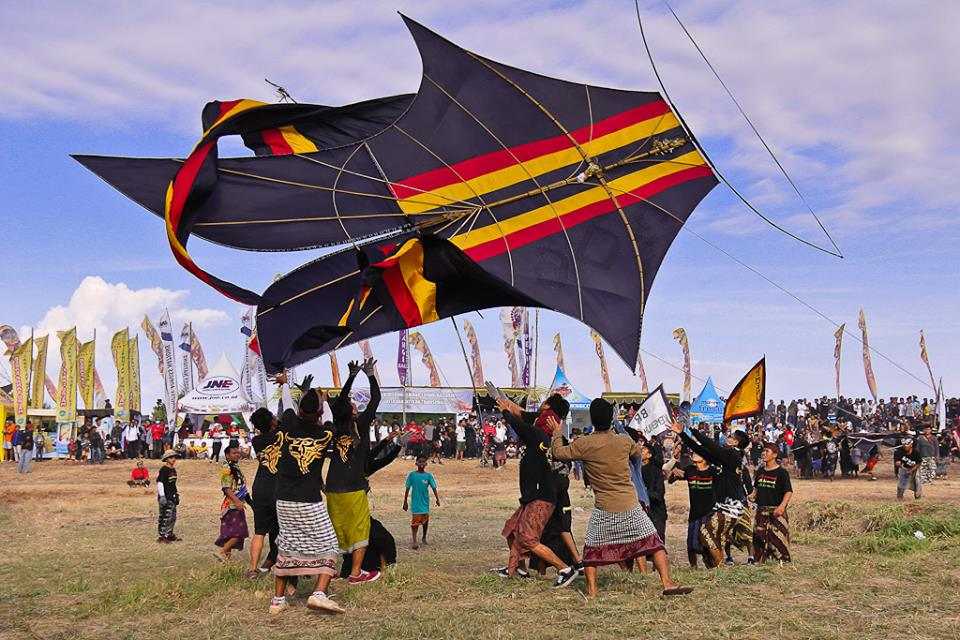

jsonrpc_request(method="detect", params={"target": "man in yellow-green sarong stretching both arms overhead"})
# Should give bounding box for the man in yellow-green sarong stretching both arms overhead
[326,358,380,584]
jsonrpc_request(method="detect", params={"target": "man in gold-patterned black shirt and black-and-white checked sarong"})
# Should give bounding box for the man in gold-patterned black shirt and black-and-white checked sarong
[270,389,343,614]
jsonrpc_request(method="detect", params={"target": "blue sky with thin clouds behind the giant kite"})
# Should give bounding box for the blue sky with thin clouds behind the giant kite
[0,0,960,400]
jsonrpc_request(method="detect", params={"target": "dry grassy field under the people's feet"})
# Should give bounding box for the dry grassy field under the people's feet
[0,460,960,640]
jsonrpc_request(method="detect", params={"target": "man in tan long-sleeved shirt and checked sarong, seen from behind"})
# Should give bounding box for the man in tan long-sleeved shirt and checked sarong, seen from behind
[549,398,693,598]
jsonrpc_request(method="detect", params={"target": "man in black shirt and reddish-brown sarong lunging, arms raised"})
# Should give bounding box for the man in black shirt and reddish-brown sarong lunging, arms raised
[497,394,578,587]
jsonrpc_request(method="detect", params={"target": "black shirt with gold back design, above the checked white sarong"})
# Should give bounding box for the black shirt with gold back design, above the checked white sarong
[276,415,333,502]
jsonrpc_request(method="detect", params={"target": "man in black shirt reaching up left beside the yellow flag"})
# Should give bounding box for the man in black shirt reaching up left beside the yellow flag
[670,422,753,566]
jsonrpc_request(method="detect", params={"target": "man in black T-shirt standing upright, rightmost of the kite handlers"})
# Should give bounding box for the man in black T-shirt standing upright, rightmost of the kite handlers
[751,442,793,562]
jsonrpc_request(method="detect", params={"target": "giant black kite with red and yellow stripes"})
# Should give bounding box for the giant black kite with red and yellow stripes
[79,18,717,371]
